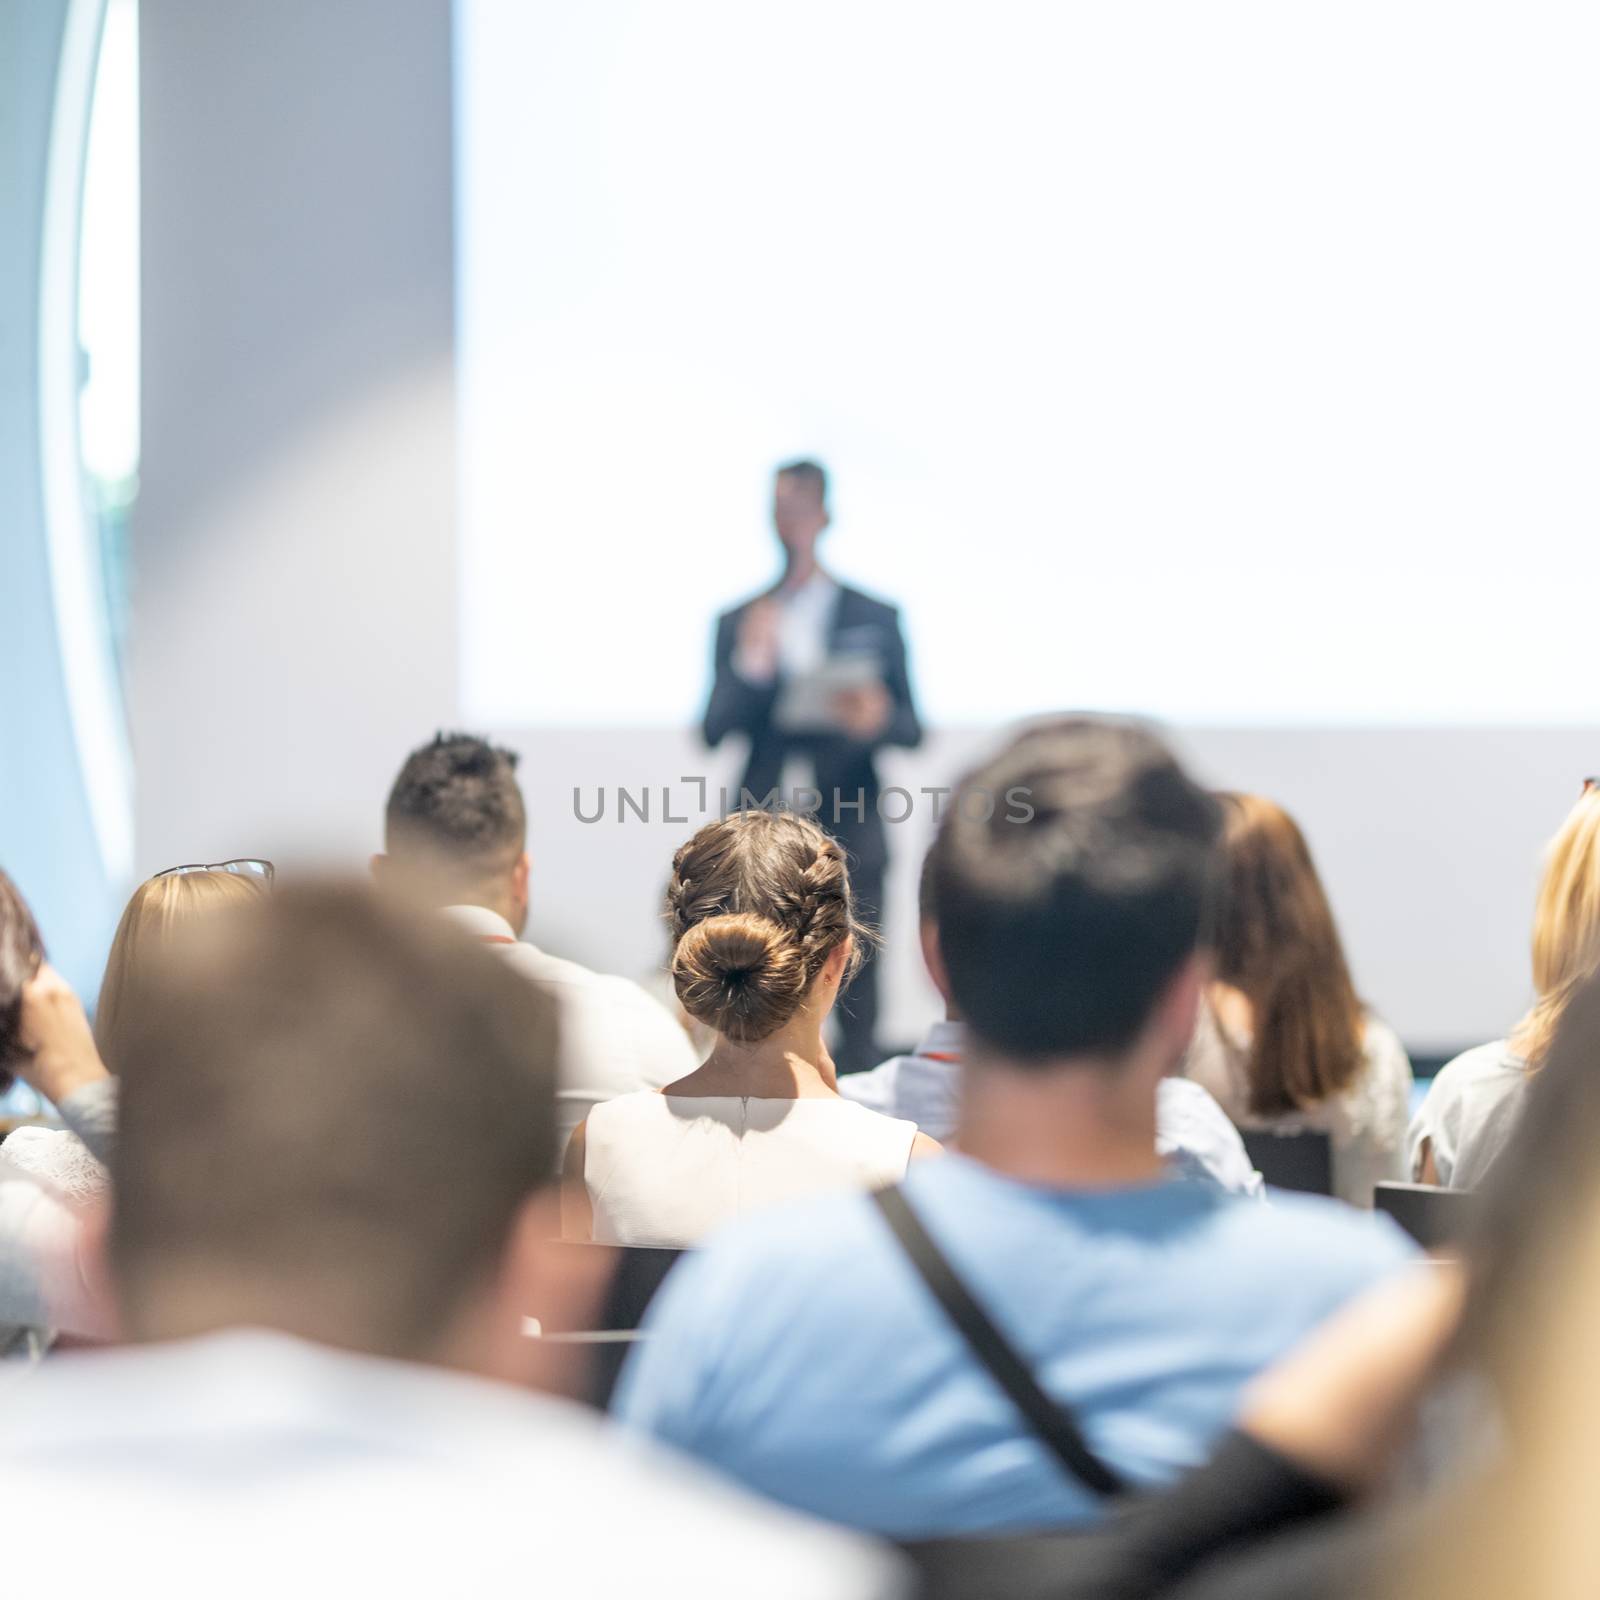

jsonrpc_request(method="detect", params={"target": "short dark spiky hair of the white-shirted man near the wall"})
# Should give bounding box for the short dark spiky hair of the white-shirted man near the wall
[384,733,528,869]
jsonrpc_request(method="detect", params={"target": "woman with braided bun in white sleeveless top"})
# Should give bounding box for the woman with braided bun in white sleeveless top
[565,811,939,1246]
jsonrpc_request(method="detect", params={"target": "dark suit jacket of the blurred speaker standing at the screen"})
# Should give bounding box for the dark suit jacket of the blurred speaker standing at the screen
[701,584,922,869]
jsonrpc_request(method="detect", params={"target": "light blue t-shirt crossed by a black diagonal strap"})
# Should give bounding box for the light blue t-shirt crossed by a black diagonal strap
[616,1154,1416,1538]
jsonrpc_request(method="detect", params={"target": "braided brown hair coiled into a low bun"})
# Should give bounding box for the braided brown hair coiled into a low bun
[667,811,870,1043]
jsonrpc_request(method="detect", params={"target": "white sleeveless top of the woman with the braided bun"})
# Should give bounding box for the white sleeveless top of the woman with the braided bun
[584,1091,917,1248]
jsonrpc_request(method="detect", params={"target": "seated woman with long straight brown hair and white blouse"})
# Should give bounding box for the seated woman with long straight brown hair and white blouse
[1184,795,1411,1206]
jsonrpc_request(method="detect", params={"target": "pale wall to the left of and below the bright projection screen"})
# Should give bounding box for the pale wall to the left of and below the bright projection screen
[131,9,1600,1050]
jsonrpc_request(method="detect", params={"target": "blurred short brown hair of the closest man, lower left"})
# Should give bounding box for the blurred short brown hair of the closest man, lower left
[109,885,557,1360]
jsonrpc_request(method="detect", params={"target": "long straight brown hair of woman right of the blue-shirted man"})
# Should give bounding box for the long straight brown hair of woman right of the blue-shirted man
[1216,794,1363,1117]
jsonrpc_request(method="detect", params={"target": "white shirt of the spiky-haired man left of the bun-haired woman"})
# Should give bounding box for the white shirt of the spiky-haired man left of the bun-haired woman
[445,906,699,1154]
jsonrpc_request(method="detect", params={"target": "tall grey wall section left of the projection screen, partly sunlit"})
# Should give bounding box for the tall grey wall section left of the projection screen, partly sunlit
[130,0,456,872]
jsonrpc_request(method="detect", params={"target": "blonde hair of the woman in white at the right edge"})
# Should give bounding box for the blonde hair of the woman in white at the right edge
[1510,789,1600,1067]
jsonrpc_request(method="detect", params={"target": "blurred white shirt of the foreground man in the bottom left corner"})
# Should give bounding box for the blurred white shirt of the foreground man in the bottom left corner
[0,1331,901,1600]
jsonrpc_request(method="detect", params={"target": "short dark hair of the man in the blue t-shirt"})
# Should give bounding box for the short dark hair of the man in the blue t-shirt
[930,717,1221,1061]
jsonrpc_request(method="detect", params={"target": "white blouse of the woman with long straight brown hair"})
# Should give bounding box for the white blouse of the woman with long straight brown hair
[1182,1005,1411,1208]
